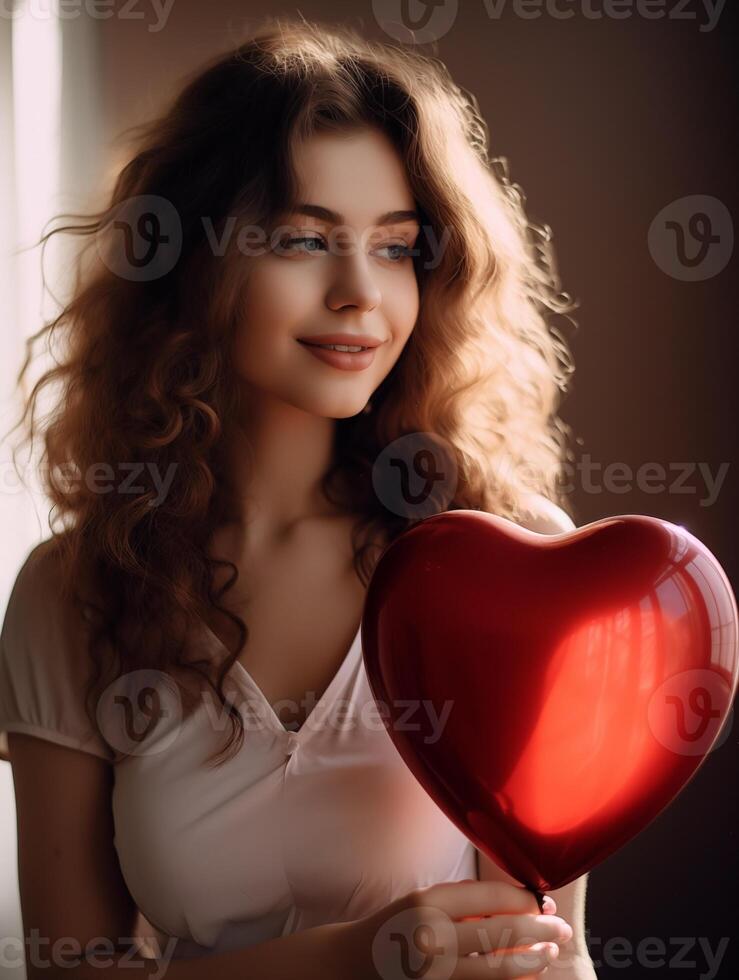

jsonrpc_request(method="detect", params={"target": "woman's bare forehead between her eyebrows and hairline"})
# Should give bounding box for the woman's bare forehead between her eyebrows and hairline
[294,129,414,224]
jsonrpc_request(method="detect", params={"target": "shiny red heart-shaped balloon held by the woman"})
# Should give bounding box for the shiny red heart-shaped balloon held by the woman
[362,510,738,892]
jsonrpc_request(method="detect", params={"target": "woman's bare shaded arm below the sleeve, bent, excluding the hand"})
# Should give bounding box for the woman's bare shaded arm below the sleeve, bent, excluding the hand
[8,732,347,980]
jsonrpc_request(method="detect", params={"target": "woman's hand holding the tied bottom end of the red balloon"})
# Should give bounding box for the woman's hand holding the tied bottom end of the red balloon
[342,879,572,980]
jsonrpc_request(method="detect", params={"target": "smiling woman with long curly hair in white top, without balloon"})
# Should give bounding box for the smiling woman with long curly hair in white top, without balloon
[0,20,594,980]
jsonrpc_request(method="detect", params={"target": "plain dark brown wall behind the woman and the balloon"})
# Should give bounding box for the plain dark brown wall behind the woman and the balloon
[95,0,739,980]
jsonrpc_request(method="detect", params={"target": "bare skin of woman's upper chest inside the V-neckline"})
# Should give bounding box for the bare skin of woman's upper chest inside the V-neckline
[209,527,365,726]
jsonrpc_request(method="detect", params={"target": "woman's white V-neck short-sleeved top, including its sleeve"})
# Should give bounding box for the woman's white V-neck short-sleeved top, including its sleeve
[0,546,477,958]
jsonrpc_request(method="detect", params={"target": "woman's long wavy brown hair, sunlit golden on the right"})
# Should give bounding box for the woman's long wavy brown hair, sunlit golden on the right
[4,18,576,765]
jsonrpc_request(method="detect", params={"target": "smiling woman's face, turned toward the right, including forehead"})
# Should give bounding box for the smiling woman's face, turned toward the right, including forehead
[233,129,420,418]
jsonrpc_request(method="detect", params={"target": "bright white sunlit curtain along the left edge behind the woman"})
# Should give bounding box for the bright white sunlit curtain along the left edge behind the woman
[0,0,105,980]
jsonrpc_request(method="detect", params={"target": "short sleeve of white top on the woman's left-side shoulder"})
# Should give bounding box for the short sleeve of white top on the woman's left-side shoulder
[0,539,114,762]
